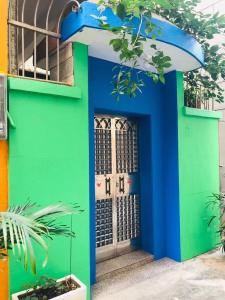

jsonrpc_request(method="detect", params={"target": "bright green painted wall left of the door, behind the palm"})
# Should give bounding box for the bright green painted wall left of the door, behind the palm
[9,44,90,293]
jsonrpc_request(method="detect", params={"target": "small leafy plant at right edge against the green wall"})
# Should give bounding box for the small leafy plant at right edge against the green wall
[207,193,225,252]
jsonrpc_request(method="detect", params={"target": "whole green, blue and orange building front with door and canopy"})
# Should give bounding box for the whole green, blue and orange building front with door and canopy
[0,0,221,300]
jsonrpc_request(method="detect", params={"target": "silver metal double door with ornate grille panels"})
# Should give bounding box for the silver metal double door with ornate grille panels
[95,116,140,262]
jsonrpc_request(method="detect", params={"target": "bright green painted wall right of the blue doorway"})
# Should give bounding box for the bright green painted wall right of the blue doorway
[177,73,219,260]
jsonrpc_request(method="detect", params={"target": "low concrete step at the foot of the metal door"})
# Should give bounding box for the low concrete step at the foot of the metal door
[96,250,154,282]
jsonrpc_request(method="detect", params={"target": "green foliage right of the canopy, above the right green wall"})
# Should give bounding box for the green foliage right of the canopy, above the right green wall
[156,0,225,106]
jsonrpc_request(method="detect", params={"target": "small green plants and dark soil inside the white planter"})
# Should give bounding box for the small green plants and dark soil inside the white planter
[20,276,79,300]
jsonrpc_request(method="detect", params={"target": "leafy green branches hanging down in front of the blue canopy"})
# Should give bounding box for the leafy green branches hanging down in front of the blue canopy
[95,0,171,99]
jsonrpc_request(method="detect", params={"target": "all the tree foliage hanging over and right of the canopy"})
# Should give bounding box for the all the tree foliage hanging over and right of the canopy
[96,0,225,105]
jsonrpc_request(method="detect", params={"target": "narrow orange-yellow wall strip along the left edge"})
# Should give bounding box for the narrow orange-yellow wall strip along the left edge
[0,0,8,300]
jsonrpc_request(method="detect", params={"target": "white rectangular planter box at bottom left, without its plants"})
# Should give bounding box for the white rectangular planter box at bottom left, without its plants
[12,275,87,300]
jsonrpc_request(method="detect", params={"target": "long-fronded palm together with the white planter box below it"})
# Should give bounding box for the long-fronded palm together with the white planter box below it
[0,203,86,300]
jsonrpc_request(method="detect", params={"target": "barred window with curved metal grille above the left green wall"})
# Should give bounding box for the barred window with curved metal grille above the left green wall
[8,0,80,84]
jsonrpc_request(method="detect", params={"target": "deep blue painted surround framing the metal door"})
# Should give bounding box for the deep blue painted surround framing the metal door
[89,57,180,284]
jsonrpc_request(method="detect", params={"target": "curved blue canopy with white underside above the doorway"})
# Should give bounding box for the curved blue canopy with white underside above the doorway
[61,2,204,72]
